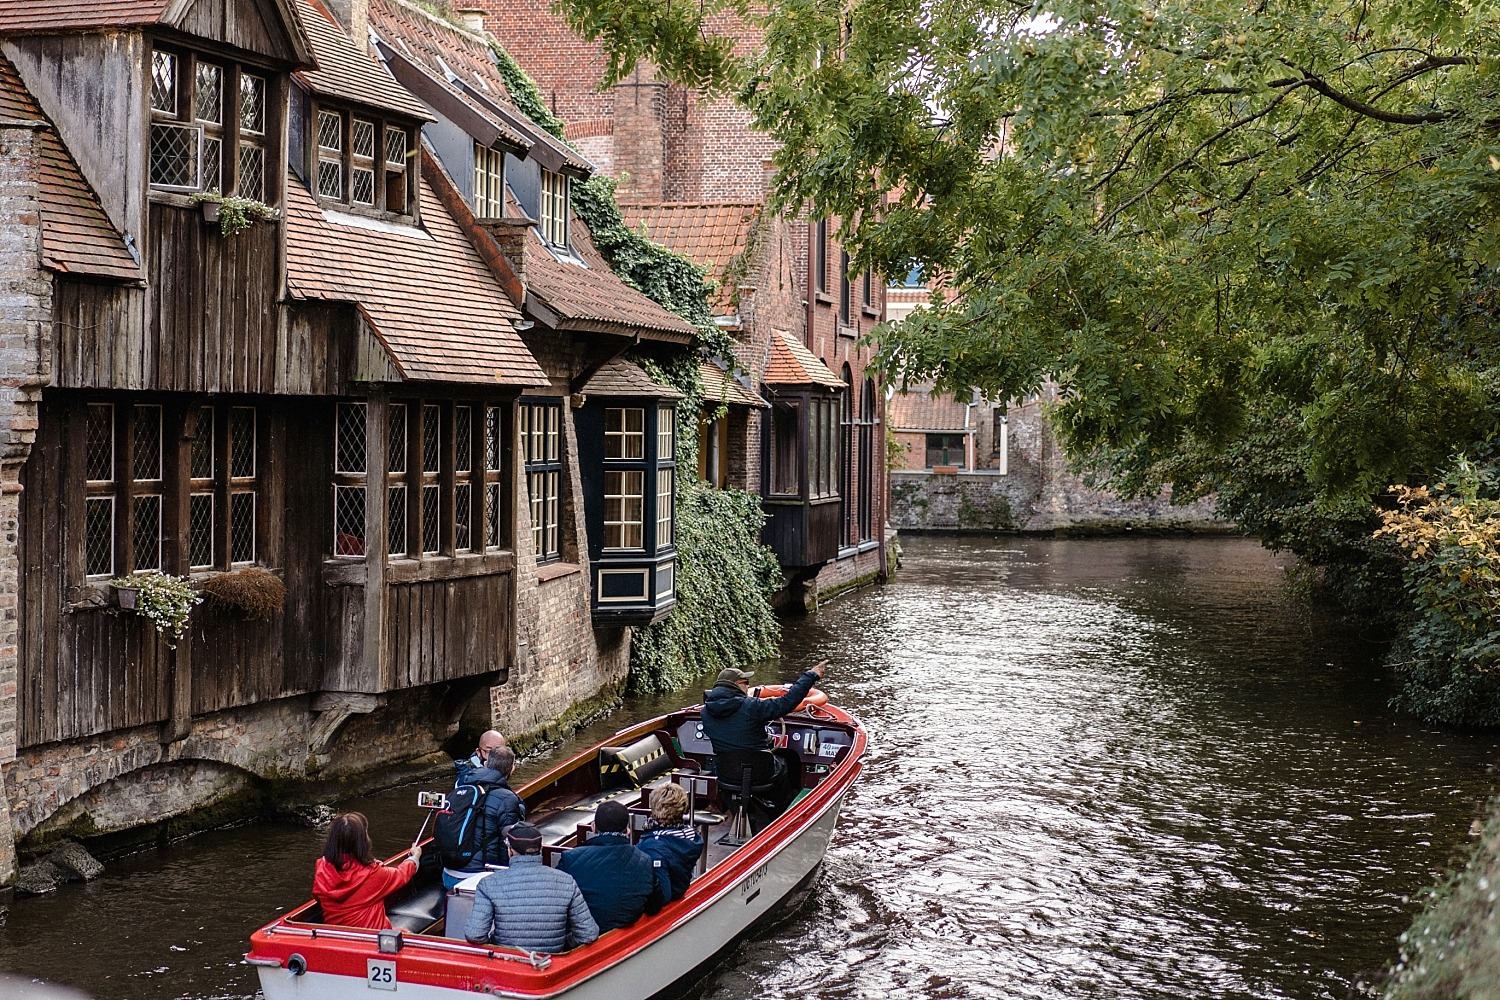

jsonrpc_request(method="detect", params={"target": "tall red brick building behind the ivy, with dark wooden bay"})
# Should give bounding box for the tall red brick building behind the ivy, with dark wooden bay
[474,0,888,600]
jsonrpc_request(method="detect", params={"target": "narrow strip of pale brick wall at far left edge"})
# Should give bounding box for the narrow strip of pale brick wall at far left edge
[0,121,53,885]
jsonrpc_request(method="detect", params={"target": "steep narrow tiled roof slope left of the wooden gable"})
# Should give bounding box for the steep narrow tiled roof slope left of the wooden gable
[0,55,143,280]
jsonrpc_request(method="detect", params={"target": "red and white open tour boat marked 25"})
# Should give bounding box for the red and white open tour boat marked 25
[245,688,867,1000]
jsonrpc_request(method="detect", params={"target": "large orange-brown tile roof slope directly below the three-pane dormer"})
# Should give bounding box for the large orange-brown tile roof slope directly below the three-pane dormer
[287,167,548,387]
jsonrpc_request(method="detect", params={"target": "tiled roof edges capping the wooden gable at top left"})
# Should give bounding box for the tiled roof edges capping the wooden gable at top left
[0,0,314,66]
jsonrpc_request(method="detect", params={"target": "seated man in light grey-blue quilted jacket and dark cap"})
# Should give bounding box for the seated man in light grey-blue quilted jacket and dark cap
[464,823,599,954]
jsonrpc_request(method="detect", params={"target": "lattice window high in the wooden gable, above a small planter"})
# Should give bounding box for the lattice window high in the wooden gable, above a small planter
[150,49,275,201]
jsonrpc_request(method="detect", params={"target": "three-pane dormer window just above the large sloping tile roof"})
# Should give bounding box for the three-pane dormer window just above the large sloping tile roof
[314,108,416,214]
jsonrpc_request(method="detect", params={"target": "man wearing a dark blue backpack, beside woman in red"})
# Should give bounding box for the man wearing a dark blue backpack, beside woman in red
[432,742,527,889]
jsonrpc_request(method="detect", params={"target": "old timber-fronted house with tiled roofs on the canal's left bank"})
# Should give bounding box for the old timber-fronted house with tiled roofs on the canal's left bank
[0,0,693,882]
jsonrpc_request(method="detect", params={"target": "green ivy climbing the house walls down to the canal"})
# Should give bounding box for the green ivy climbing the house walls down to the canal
[491,43,782,691]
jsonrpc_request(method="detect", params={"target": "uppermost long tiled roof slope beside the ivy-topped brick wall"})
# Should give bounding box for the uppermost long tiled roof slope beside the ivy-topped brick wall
[371,0,594,177]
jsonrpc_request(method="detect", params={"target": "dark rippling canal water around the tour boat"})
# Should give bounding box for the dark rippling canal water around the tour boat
[0,538,1500,1000]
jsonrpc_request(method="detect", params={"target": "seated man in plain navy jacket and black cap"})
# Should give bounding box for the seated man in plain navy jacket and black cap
[558,802,672,934]
